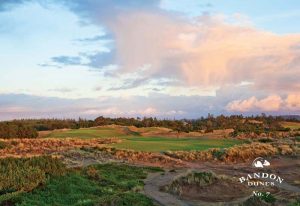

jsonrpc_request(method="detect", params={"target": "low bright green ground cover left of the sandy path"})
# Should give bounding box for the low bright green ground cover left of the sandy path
[17,164,157,206]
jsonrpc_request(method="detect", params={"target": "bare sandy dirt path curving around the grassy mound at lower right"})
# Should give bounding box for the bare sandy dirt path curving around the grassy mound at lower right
[144,159,300,206]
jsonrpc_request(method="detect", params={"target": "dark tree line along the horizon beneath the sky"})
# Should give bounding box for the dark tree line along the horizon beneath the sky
[0,114,299,138]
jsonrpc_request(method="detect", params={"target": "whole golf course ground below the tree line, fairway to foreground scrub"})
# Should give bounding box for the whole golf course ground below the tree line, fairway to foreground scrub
[0,124,300,206]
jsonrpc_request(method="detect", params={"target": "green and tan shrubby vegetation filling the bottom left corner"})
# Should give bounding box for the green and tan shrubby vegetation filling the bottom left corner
[0,157,160,206]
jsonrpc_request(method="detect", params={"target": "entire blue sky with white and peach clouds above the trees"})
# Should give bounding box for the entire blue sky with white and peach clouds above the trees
[0,0,300,120]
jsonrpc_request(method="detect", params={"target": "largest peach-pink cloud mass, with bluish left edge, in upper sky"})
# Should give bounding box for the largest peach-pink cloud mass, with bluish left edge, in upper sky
[61,0,300,93]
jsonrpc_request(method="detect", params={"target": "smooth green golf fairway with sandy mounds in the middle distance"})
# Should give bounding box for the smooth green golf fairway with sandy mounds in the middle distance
[45,126,243,152]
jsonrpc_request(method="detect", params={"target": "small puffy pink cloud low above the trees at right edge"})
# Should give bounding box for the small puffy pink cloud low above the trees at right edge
[226,94,300,112]
